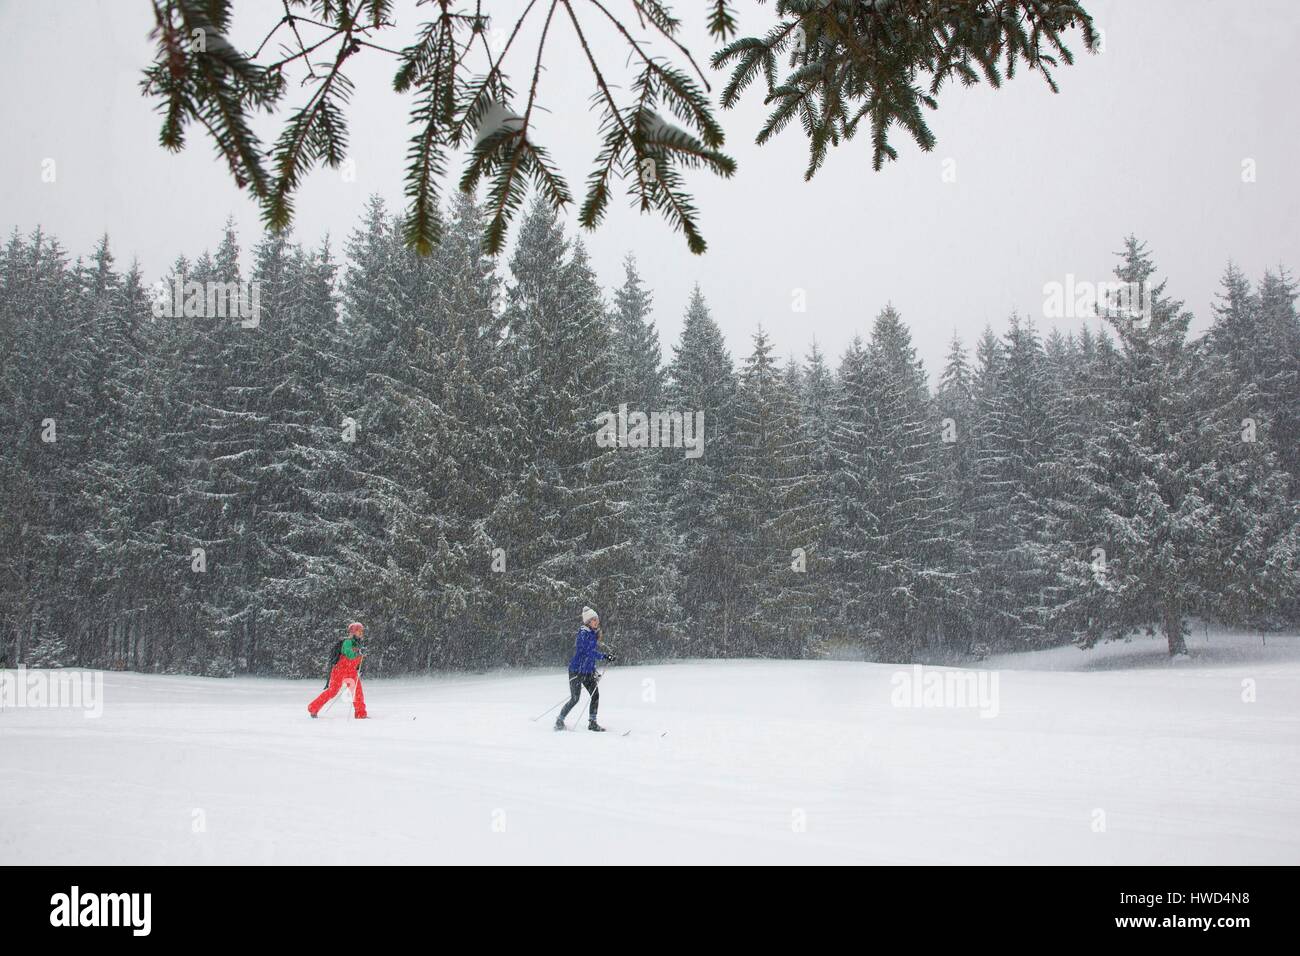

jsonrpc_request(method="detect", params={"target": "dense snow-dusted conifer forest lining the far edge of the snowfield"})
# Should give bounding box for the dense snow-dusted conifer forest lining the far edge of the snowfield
[0,196,1300,675]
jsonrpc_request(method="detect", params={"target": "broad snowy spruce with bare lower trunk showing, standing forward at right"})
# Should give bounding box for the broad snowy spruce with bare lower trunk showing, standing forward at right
[1063,237,1295,656]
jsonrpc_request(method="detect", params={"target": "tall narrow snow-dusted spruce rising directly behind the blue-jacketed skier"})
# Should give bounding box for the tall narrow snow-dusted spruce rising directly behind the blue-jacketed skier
[490,199,631,662]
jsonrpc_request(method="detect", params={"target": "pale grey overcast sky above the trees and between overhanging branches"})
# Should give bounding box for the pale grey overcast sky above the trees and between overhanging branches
[0,0,1300,375]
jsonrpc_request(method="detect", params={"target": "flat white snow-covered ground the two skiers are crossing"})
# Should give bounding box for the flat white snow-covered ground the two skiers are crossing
[0,633,1300,865]
